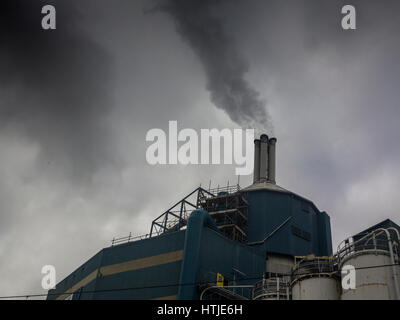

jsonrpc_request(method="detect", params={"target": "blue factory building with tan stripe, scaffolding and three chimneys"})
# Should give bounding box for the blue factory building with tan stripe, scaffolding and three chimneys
[47,135,400,300]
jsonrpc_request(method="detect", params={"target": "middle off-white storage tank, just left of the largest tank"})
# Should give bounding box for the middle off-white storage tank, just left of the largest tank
[291,256,341,300]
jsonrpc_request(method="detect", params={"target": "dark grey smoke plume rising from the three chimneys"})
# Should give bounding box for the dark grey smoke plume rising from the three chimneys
[154,0,271,131]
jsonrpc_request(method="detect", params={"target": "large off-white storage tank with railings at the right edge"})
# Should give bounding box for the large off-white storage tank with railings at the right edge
[338,229,400,300]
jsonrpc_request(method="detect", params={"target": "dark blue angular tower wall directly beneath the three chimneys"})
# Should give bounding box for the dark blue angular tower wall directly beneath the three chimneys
[246,190,332,256]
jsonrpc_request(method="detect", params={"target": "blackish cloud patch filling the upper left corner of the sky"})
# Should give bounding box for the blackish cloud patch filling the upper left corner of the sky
[0,0,115,182]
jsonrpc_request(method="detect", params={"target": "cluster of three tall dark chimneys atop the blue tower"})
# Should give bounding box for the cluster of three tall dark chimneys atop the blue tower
[253,134,277,184]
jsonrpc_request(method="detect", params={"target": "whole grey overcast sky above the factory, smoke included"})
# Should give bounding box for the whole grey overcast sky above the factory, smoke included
[0,0,400,296]
